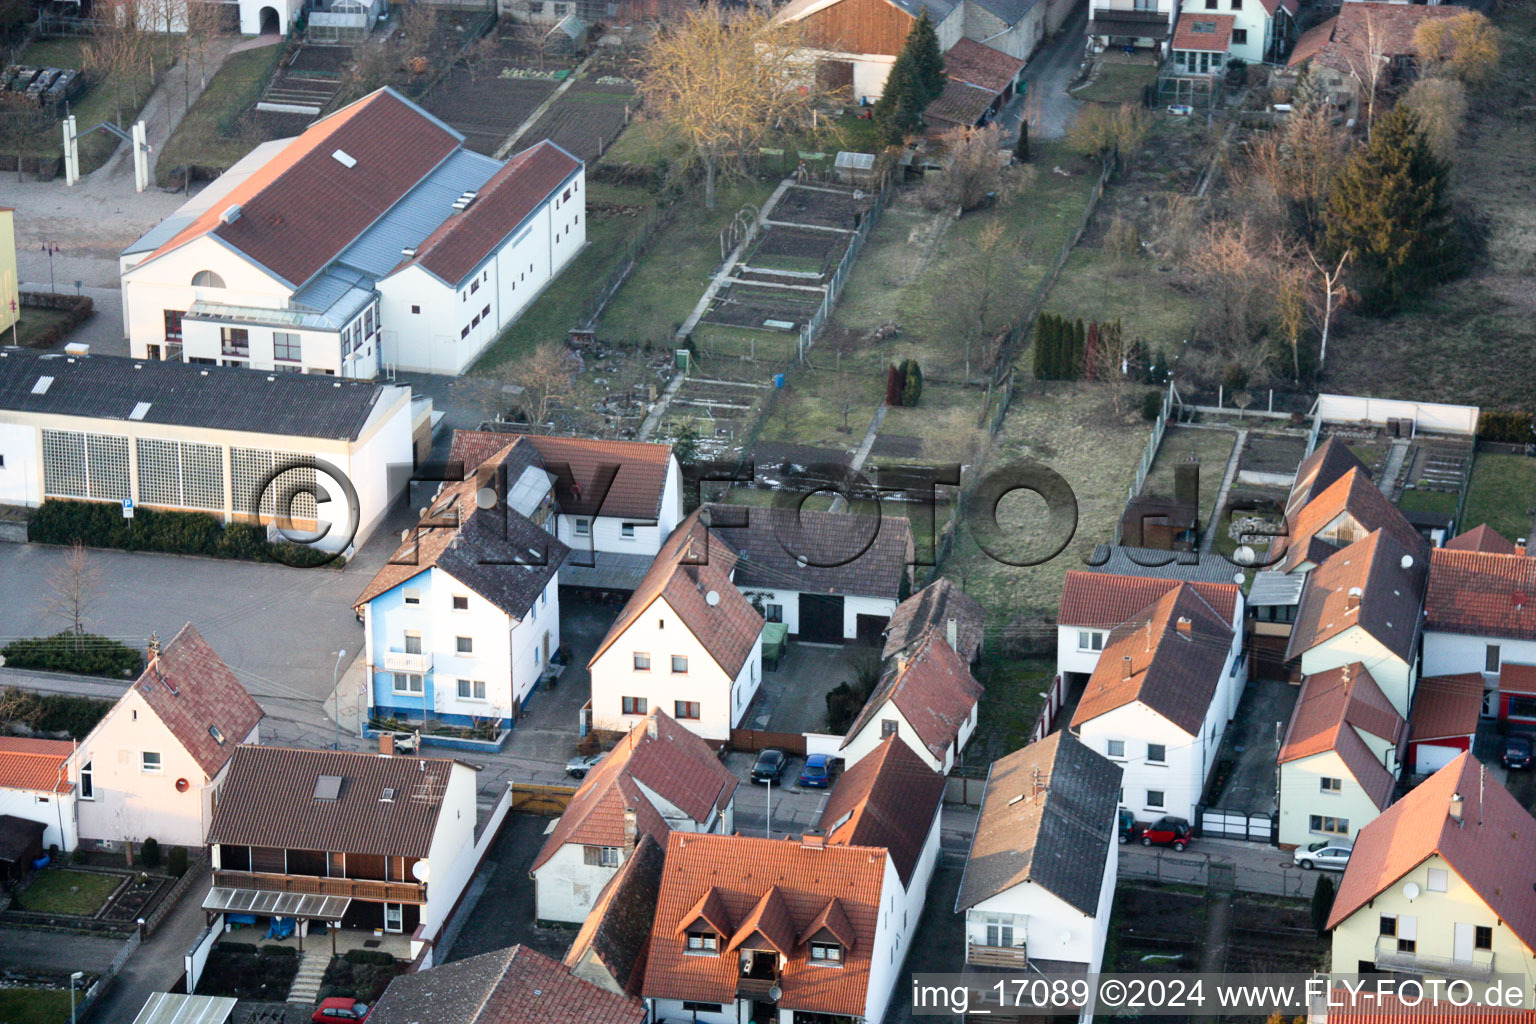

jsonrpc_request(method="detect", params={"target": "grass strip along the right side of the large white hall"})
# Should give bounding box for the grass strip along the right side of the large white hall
[473,181,660,375]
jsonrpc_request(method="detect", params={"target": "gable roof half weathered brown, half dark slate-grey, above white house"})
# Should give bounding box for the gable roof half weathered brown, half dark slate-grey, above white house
[955,729,1121,917]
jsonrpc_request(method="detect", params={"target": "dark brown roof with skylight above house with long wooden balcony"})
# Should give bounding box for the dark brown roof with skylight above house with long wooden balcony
[207,745,455,857]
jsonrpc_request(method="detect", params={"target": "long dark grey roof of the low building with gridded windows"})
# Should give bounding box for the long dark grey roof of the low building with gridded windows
[0,347,392,441]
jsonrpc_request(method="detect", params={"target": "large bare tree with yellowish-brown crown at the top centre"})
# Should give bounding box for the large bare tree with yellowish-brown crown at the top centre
[641,6,833,209]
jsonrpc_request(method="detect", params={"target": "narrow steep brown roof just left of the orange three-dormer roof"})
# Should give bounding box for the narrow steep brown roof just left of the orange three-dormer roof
[565,835,667,996]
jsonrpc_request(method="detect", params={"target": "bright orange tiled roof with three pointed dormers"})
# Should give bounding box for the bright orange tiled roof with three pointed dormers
[644,832,885,1016]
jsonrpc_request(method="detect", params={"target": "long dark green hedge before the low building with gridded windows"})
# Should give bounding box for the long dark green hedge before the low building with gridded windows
[26,500,336,567]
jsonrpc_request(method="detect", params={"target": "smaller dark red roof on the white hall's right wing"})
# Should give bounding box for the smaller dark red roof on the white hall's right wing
[392,140,581,286]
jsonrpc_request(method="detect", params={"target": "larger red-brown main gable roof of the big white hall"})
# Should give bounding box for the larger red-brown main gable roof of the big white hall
[146,89,461,287]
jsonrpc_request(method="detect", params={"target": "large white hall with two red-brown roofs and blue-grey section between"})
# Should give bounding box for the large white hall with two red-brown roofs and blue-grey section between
[120,89,587,378]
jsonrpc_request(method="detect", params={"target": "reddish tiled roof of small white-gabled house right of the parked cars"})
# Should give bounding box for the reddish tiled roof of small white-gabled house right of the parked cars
[842,629,982,760]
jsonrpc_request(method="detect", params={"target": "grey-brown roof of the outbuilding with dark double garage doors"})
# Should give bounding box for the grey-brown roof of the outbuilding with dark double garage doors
[705,504,912,599]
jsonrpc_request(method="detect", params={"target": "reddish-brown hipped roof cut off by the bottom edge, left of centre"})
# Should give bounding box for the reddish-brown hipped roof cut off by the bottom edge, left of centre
[369,946,647,1024]
